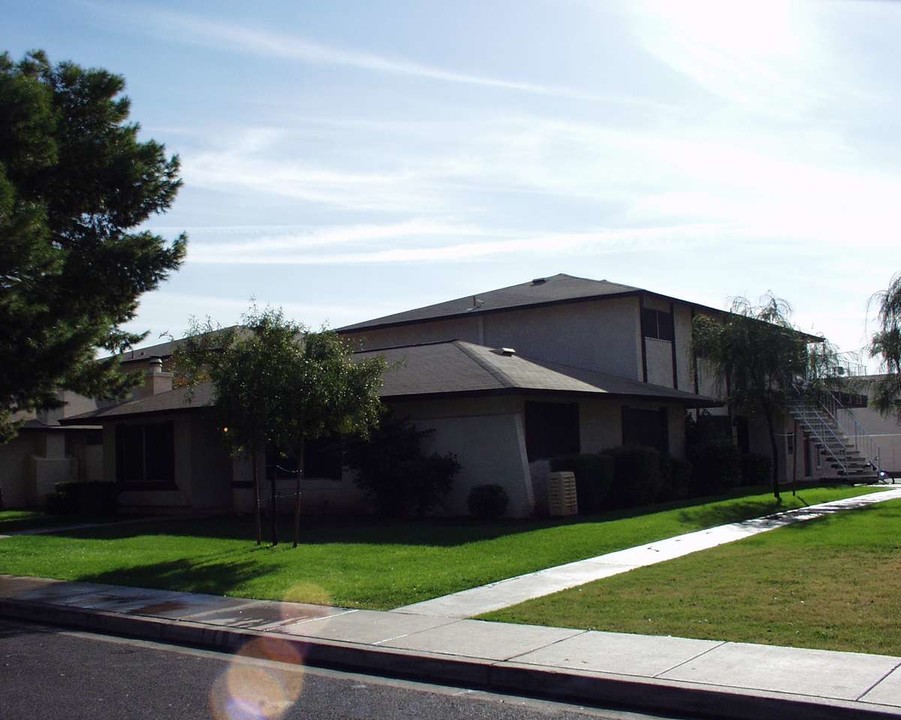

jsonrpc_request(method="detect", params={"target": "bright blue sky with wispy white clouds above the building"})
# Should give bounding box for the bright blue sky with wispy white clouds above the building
[0,0,901,368]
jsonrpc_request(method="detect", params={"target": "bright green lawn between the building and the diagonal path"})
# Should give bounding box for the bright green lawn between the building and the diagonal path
[0,488,884,609]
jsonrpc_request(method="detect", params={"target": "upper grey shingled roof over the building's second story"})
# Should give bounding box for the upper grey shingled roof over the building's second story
[338,273,663,333]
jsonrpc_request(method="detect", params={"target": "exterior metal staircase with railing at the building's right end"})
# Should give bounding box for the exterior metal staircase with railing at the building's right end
[788,385,885,482]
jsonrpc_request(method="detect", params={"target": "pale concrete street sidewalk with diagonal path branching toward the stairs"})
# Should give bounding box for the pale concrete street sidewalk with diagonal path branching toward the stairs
[0,489,901,720]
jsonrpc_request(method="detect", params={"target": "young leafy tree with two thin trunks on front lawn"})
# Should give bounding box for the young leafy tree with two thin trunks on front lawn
[175,308,385,547]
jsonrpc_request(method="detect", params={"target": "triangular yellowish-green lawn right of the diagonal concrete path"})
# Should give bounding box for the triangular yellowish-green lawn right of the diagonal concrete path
[484,501,901,655]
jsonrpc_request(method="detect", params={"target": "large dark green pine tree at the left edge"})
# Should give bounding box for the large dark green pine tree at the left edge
[0,52,186,442]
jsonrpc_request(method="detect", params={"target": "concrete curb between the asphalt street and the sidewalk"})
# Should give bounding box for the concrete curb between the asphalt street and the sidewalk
[0,598,901,720]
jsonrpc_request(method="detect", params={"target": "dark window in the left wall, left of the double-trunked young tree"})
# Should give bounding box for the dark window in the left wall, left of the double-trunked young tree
[116,421,175,487]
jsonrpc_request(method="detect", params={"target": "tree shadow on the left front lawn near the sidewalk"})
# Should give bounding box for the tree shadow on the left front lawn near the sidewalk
[76,560,270,595]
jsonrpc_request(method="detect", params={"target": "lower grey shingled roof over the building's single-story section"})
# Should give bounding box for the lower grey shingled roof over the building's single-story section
[63,340,721,424]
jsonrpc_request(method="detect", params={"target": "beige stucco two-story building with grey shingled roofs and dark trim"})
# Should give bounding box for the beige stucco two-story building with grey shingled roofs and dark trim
[10,275,868,516]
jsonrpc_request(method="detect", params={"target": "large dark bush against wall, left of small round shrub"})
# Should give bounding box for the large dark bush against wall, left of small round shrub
[345,416,460,517]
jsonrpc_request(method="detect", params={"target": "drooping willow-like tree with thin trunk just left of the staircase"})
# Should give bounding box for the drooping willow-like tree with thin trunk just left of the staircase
[692,296,831,500]
